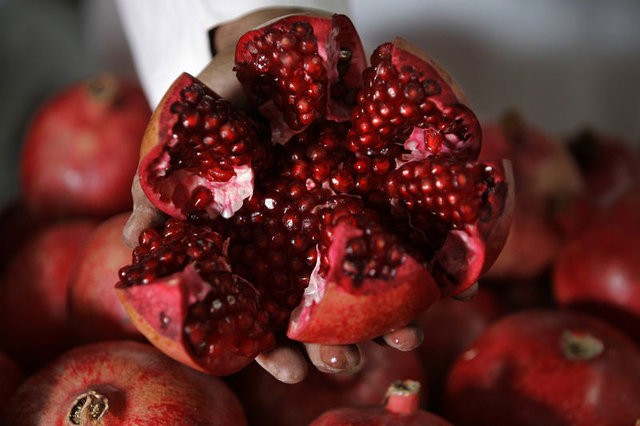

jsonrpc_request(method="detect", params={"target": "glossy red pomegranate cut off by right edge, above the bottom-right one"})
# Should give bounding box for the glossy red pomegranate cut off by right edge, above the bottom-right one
[553,187,640,342]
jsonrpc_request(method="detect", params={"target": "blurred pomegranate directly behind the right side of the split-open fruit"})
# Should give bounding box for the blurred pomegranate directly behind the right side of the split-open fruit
[480,111,583,279]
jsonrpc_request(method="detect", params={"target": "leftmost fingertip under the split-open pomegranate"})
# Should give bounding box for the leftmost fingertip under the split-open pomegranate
[256,346,308,384]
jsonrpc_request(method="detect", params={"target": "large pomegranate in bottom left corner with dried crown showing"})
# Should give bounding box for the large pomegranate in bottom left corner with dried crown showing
[0,341,246,426]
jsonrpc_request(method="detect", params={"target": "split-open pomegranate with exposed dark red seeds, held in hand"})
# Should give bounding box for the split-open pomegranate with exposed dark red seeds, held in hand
[125,12,512,372]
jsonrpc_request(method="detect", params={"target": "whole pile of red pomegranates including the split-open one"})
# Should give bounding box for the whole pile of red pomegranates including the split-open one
[0,14,640,426]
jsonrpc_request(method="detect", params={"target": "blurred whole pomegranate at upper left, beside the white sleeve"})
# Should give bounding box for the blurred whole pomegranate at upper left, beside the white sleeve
[20,74,151,218]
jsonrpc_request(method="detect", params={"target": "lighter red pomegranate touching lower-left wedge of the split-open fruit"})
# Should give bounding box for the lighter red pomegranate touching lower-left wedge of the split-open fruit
[68,213,143,343]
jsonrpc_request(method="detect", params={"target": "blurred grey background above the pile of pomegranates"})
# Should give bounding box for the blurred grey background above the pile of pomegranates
[0,0,640,210]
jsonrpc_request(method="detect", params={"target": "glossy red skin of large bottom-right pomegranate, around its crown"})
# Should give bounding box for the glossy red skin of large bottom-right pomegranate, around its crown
[445,310,640,426]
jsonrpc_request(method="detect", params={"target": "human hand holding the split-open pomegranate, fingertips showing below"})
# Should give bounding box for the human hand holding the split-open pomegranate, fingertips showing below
[123,8,475,383]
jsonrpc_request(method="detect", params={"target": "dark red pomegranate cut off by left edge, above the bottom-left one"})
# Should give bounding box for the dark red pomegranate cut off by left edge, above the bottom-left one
[0,219,97,369]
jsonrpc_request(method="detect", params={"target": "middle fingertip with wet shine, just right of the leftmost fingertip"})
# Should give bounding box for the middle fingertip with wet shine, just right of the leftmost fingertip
[305,343,365,373]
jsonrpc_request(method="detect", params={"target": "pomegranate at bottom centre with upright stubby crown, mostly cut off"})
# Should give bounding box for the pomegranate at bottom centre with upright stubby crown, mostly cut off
[309,380,451,426]
